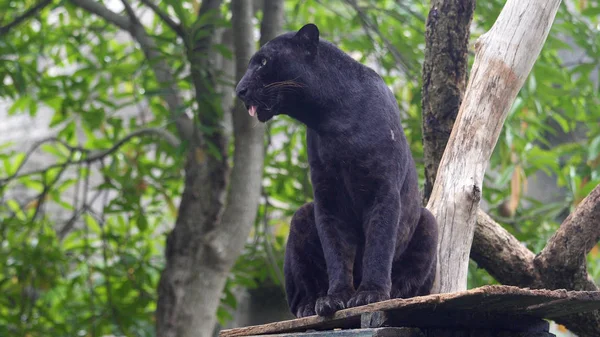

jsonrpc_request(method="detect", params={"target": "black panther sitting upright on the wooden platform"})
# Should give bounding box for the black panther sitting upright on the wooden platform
[236,24,437,317]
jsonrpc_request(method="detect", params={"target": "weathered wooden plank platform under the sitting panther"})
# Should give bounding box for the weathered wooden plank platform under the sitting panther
[219,286,600,337]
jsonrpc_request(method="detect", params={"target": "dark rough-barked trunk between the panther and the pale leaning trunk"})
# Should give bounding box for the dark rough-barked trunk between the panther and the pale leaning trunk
[421,0,475,204]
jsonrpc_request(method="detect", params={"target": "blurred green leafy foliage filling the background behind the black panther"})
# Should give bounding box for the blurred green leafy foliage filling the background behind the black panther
[0,0,600,336]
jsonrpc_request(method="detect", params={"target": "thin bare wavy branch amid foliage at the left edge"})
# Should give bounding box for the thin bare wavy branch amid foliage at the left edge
[0,128,180,186]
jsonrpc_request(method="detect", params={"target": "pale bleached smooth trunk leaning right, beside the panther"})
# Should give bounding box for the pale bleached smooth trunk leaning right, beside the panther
[427,0,560,293]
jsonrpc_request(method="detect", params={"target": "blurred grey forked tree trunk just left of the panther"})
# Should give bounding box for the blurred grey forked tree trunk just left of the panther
[157,1,283,337]
